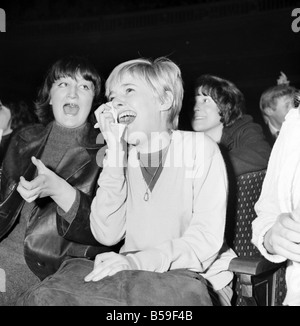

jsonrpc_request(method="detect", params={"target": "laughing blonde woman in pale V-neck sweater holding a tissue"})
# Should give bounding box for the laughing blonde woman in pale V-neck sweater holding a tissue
[18,57,235,306]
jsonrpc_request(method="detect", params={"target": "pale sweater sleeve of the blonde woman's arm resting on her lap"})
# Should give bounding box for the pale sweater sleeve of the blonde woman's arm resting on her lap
[128,139,227,272]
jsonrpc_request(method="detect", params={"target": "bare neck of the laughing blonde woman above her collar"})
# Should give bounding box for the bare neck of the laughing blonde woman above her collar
[136,130,172,154]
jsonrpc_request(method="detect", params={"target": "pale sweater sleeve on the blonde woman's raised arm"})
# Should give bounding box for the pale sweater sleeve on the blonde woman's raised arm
[90,150,127,246]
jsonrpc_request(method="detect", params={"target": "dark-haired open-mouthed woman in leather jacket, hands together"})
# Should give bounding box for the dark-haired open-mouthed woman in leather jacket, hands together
[0,56,115,306]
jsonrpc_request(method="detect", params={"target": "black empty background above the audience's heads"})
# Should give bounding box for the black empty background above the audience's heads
[0,0,300,129]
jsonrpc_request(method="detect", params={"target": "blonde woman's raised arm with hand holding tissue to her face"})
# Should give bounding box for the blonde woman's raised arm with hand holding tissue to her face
[90,104,127,245]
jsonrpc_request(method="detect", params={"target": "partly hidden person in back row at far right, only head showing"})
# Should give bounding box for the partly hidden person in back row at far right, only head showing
[259,72,297,146]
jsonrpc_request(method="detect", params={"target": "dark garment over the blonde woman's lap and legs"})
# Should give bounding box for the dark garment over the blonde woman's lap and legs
[17,258,213,306]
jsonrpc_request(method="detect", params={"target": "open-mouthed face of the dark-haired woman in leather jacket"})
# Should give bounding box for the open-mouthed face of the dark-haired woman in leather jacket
[50,75,94,128]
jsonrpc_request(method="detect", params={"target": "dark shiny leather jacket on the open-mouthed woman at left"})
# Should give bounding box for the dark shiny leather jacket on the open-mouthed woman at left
[0,123,114,279]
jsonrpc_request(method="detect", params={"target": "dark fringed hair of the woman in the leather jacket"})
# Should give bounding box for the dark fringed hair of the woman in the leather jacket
[34,56,101,125]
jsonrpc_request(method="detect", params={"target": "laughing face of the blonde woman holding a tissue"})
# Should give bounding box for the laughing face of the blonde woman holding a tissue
[108,73,166,146]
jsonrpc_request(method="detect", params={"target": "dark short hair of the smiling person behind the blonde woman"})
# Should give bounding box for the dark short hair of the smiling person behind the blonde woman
[195,74,245,127]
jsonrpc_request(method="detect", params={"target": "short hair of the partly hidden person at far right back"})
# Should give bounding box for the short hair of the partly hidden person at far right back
[259,84,297,113]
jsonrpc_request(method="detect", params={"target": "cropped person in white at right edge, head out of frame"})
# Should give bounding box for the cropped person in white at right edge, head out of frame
[252,99,300,306]
